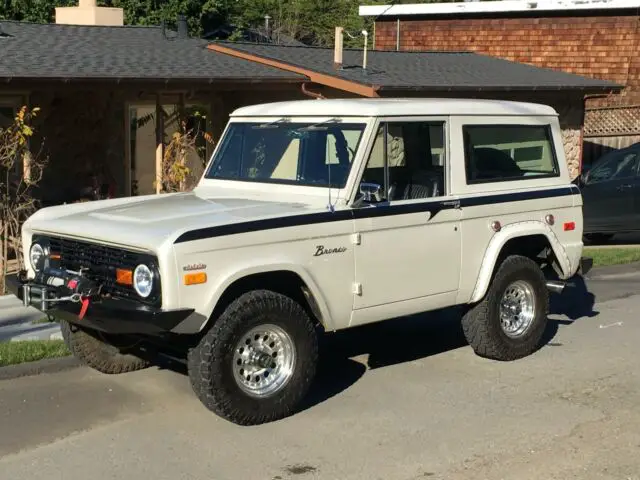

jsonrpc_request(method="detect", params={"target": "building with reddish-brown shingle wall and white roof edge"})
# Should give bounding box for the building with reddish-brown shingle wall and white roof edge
[360,0,640,164]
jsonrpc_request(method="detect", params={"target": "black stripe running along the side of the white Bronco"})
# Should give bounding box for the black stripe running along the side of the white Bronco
[174,185,580,244]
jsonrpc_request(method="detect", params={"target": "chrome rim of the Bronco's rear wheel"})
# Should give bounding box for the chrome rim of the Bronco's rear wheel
[500,280,536,338]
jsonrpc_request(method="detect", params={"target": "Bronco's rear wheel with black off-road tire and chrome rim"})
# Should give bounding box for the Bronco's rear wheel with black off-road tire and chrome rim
[462,255,549,361]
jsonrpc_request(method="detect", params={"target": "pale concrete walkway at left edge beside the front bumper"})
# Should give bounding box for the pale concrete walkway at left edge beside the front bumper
[0,295,62,342]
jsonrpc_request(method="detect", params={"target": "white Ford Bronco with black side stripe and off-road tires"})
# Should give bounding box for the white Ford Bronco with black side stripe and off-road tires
[9,99,589,425]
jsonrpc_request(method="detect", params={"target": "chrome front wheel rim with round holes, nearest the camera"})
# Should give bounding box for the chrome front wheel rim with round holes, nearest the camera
[233,325,296,397]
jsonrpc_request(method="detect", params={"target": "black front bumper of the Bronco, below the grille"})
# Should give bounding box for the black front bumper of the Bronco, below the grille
[6,275,202,336]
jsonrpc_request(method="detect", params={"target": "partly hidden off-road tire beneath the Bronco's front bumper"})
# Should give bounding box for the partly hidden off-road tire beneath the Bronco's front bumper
[60,320,150,375]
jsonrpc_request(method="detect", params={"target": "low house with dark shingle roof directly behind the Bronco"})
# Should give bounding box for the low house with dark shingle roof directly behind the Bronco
[0,0,621,204]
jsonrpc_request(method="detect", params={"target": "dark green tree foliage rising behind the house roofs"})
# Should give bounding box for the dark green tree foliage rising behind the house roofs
[0,0,460,48]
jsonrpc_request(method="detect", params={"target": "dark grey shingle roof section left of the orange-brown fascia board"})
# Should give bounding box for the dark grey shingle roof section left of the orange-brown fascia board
[0,21,305,81]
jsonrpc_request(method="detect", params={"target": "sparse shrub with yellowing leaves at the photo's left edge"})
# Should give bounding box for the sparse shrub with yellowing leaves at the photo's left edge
[0,106,46,291]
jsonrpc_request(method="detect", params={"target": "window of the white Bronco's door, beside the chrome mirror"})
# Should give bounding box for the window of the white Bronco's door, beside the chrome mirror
[362,122,445,201]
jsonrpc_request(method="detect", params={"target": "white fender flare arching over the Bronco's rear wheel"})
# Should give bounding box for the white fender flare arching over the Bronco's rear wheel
[469,220,573,303]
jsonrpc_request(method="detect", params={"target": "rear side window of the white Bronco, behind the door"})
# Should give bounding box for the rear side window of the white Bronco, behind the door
[462,125,560,184]
